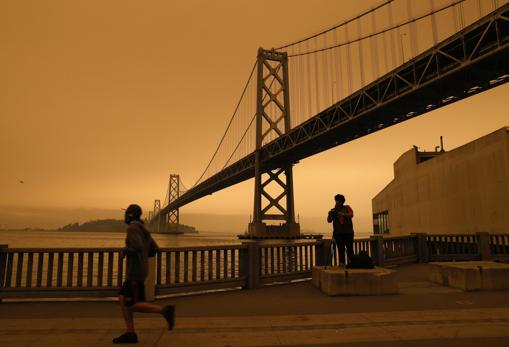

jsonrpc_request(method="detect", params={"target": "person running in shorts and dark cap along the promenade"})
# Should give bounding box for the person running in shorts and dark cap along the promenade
[113,204,175,343]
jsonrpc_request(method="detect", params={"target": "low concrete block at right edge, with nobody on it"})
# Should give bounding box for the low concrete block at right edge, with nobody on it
[429,261,509,291]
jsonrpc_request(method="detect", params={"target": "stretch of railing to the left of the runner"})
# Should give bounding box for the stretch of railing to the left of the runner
[0,248,125,297]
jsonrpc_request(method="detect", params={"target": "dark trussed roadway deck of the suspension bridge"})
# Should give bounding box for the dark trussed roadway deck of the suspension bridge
[154,4,509,219]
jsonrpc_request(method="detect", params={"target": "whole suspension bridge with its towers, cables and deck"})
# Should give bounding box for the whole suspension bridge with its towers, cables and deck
[149,0,509,238]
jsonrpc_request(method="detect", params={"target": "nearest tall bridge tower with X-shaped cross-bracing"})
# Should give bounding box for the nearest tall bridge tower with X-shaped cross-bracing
[248,48,300,238]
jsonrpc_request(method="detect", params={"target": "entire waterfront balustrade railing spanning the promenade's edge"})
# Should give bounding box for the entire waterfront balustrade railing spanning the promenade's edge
[0,233,509,299]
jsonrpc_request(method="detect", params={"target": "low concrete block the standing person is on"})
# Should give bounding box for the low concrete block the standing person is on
[315,267,398,296]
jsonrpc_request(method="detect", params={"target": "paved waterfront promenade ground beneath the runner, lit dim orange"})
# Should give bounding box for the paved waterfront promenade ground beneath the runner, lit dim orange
[0,264,509,347]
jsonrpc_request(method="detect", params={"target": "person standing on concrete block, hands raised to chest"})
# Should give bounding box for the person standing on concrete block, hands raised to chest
[327,194,353,265]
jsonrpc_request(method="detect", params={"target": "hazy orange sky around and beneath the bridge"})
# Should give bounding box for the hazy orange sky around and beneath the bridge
[0,0,509,234]
